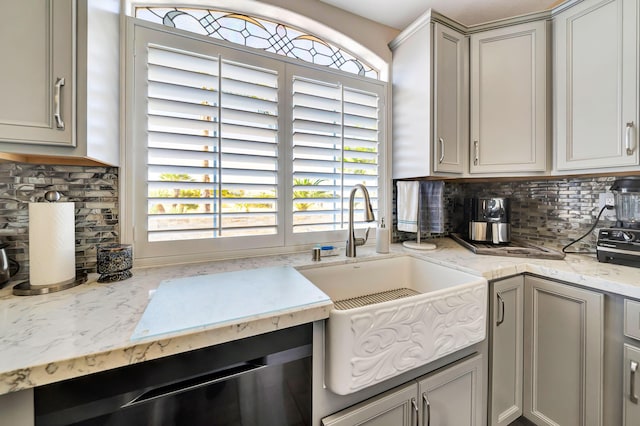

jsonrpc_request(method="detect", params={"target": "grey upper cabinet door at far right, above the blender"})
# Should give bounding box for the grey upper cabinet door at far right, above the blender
[553,0,639,170]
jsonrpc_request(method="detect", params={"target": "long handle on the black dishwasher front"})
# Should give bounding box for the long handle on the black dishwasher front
[120,360,268,408]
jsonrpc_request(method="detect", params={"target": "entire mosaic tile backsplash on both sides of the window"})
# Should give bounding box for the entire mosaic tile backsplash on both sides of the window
[0,163,615,288]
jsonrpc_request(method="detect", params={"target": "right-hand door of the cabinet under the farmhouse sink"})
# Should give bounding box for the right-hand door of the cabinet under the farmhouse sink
[418,355,484,426]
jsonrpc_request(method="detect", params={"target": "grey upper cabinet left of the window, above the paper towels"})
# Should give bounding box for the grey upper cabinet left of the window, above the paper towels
[0,0,120,165]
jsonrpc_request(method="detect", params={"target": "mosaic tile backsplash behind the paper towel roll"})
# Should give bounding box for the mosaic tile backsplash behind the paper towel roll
[0,163,119,282]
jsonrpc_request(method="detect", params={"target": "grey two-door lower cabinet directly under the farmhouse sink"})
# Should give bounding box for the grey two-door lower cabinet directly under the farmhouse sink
[322,354,483,426]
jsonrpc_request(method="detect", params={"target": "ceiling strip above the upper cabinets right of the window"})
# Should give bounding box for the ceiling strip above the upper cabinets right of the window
[320,0,562,30]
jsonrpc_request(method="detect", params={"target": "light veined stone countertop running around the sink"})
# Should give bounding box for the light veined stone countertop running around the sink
[0,238,640,395]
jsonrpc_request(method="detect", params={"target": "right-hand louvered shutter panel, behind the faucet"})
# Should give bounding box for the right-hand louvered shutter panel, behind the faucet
[292,76,379,233]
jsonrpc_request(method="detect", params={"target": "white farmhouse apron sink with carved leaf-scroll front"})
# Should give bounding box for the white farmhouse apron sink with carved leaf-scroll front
[299,256,487,395]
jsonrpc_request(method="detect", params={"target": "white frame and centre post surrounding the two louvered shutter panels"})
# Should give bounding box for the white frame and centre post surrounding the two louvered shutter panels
[120,17,390,266]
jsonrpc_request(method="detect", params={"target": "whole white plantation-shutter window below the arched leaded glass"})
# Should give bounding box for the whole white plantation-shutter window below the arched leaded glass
[124,24,387,263]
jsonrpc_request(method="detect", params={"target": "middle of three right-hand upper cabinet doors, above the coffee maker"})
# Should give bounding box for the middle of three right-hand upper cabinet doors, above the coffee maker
[469,21,547,173]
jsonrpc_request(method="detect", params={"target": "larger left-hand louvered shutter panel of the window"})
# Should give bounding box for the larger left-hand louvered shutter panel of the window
[146,45,279,242]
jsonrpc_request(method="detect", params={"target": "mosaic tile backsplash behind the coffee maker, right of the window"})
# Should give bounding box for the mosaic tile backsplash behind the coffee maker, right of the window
[393,177,615,251]
